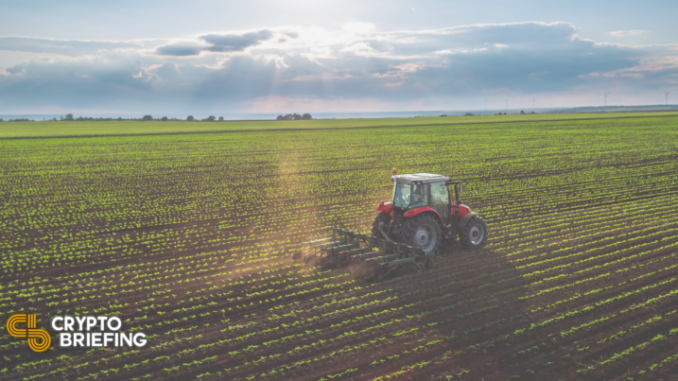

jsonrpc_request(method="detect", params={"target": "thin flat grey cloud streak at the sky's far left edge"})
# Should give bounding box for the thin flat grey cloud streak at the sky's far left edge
[0,37,141,56]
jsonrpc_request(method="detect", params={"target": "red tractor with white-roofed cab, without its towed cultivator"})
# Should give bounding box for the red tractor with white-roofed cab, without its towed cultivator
[372,170,487,252]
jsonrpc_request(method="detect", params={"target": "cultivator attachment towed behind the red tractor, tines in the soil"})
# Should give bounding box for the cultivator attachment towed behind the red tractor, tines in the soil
[304,223,435,279]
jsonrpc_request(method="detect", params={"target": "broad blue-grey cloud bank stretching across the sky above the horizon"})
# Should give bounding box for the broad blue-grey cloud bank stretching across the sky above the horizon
[0,22,678,113]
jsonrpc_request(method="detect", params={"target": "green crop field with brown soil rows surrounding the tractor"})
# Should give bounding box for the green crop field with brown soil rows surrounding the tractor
[0,114,678,381]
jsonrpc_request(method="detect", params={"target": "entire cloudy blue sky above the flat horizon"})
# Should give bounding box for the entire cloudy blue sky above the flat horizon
[0,0,678,116]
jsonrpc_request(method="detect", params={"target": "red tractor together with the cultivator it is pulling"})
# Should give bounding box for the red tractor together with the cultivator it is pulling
[304,169,487,278]
